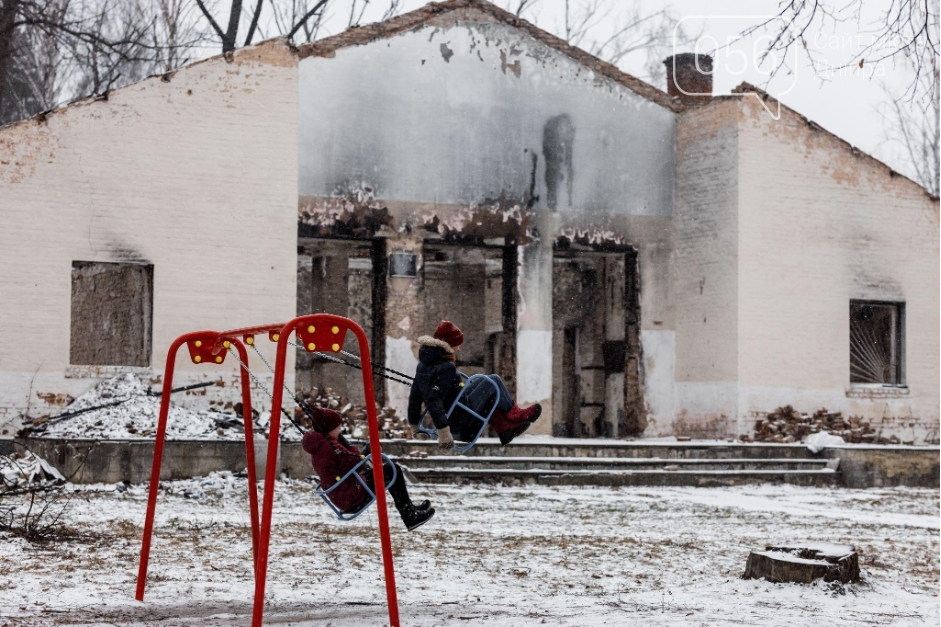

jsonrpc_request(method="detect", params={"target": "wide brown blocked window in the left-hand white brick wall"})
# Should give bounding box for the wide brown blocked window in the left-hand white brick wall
[70,261,154,367]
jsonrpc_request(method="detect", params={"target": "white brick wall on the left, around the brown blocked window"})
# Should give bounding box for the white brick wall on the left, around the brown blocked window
[0,42,297,431]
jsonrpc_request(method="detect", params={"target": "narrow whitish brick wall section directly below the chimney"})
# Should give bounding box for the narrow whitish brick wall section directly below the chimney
[668,101,739,436]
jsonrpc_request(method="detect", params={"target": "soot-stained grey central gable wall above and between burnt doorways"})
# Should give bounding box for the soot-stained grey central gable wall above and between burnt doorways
[298,8,676,434]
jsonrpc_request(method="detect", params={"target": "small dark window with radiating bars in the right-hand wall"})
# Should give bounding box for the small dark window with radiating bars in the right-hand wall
[850,301,905,386]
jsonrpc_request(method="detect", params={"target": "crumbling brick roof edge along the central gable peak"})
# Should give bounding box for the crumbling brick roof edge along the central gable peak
[297,0,685,113]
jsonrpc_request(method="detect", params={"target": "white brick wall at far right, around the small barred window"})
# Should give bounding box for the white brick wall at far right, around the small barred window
[739,99,941,440]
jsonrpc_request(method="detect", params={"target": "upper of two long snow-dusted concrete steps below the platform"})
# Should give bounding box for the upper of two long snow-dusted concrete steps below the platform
[393,456,838,472]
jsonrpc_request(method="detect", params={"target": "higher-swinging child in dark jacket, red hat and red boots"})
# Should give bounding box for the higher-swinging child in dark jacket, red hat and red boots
[408,320,542,451]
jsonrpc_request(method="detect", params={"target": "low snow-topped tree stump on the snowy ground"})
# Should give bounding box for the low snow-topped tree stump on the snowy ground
[744,542,859,584]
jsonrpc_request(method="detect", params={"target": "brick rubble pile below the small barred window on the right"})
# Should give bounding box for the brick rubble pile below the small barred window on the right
[742,405,901,444]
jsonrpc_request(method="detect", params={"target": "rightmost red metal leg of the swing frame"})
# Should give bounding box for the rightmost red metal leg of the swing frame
[346,321,404,627]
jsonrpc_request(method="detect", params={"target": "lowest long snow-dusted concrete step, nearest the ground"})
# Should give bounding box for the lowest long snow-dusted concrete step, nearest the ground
[411,468,841,487]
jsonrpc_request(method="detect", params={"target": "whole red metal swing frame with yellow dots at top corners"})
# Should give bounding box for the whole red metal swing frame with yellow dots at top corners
[136,314,401,627]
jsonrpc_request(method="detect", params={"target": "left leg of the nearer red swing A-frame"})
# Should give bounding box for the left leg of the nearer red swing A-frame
[252,321,294,627]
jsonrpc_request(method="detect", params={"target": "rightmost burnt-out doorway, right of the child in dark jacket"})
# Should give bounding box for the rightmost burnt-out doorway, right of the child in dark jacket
[552,248,645,438]
